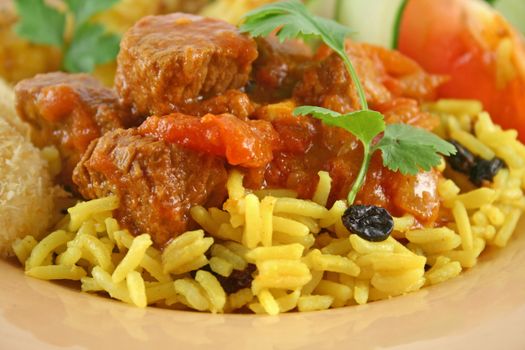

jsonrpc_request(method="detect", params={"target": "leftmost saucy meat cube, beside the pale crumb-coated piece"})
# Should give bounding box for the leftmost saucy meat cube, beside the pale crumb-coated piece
[15,72,132,189]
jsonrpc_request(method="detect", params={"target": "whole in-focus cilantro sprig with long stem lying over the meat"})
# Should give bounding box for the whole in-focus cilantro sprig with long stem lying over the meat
[240,0,456,205]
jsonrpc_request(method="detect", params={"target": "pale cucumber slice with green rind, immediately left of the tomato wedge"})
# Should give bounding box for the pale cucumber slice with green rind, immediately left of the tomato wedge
[336,0,406,48]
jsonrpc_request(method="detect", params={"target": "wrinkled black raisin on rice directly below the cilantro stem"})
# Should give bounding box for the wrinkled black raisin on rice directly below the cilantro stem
[342,205,394,242]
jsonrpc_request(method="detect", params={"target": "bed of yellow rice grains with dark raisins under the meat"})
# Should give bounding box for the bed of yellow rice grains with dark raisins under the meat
[13,100,525,315]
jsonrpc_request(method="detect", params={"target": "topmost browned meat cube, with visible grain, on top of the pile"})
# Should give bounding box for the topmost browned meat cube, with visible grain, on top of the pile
[115,13,257,116]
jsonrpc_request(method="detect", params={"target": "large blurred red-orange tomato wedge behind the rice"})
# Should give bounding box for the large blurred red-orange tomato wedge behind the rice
[399,0,525,141]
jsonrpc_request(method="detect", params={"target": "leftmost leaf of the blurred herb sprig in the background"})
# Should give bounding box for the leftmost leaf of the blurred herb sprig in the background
[15,0,66,47]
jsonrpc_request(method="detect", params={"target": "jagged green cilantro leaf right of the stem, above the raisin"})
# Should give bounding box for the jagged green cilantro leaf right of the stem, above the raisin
[374,124,456,175]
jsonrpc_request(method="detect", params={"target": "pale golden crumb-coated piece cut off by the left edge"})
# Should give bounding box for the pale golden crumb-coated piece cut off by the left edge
[0,81,56,257]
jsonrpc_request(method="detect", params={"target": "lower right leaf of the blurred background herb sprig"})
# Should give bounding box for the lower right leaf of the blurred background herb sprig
[64,23,120,72]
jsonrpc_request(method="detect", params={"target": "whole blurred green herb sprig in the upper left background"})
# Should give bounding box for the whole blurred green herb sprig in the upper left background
[15,0,120,72]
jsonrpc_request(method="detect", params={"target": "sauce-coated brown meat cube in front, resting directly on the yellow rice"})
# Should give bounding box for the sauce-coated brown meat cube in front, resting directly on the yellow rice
[73,129,227,246]
